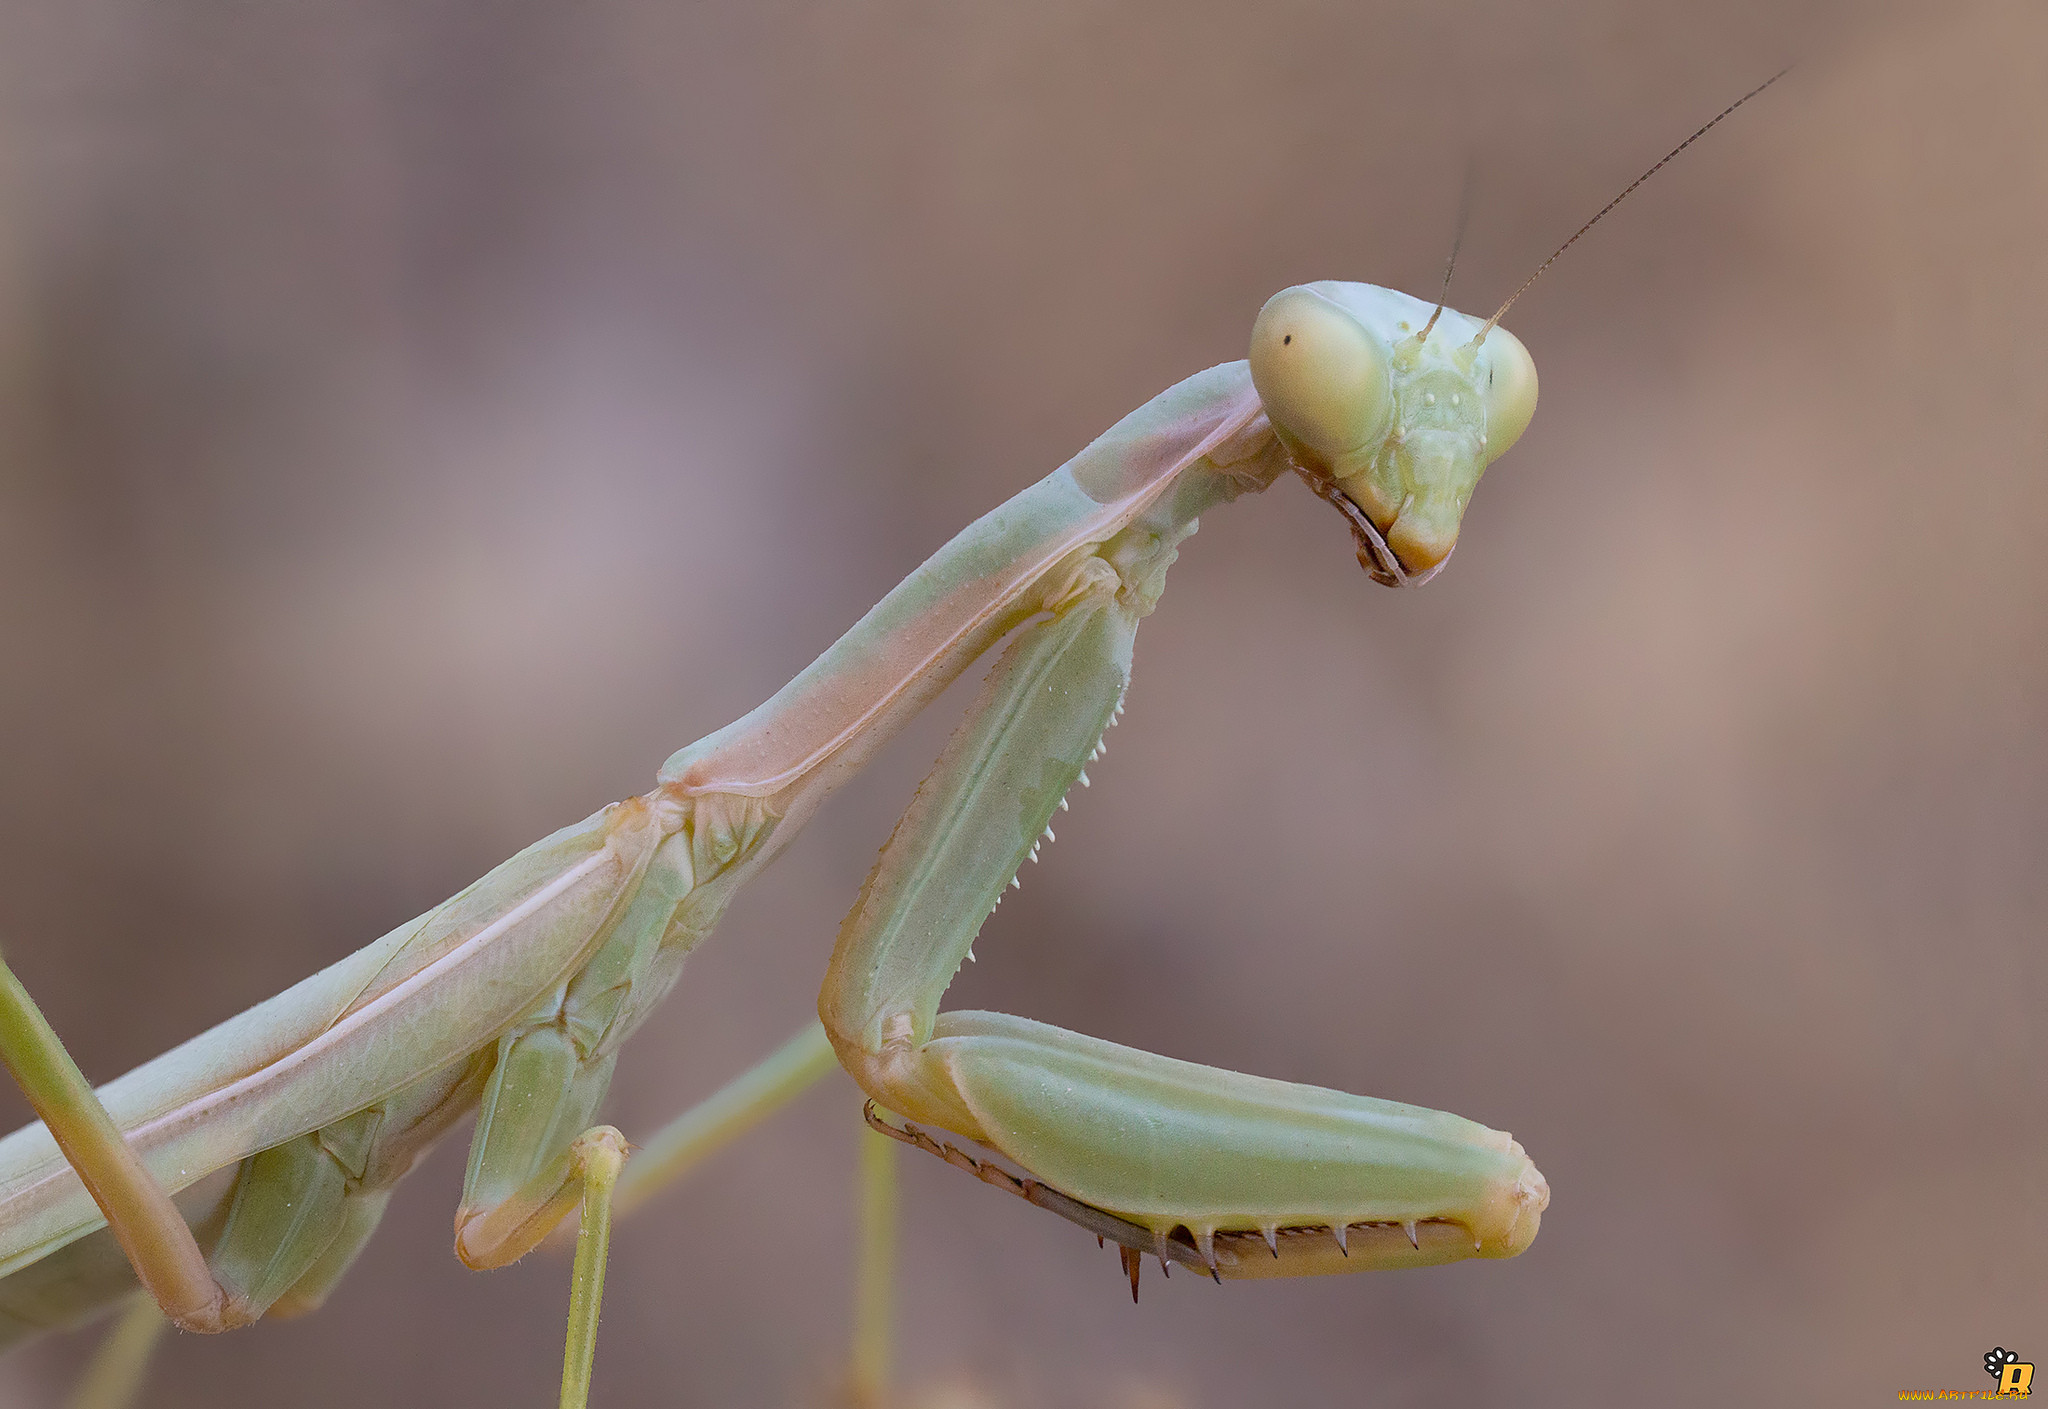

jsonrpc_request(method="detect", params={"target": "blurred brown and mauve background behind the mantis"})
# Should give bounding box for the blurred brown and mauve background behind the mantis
[0,0,2048,1409]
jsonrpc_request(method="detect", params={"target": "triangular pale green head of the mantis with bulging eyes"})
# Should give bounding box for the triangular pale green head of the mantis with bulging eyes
[1251,281,1536,584]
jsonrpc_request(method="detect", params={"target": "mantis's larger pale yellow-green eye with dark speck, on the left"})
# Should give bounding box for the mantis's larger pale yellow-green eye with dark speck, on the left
[1251,287,1391,469]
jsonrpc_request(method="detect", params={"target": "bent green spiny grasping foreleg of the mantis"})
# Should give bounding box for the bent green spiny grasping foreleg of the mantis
[819,528,1548,1276]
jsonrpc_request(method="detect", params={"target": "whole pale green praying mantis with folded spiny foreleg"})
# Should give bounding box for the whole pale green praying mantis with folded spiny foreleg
[0,79,1761,1403]
